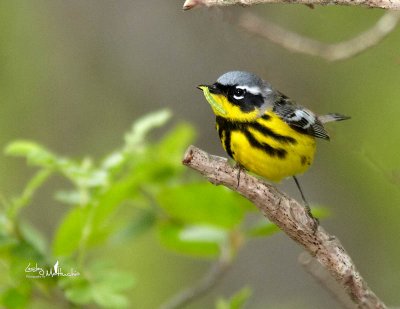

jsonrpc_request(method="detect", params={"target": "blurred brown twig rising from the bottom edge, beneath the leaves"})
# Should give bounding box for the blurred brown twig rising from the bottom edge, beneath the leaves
[159,243,232,309]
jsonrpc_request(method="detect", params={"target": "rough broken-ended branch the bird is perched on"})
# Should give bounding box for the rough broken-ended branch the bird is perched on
[183,146,386,309]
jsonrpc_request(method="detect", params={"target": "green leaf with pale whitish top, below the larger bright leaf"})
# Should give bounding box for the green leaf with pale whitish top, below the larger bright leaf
[158,222,228,257]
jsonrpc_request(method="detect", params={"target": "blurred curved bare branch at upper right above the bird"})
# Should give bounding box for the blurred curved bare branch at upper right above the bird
[239,11,400,61]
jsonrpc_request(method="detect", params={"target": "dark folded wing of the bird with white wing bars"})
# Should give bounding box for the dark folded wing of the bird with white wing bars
[273,92,329,139]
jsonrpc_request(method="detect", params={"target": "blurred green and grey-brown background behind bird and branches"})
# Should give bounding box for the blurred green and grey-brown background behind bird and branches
[0,0,400,308]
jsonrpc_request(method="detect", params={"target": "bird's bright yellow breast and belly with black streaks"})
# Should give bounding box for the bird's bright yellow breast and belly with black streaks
[217,111,315,181]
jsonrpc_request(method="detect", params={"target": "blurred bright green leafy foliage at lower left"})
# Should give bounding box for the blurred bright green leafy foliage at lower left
[0,110,328,308]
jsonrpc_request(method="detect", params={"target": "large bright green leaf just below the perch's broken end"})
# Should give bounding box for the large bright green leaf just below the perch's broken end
[157,183,249,228]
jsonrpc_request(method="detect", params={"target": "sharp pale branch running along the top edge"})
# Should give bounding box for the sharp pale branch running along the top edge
[183,0,400,10]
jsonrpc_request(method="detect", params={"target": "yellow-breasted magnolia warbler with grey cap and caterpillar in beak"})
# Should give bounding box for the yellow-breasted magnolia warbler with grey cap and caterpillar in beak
[198,71,350,217]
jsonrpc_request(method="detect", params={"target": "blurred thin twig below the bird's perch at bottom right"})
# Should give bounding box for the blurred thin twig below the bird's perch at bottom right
[299,252,356,309]
